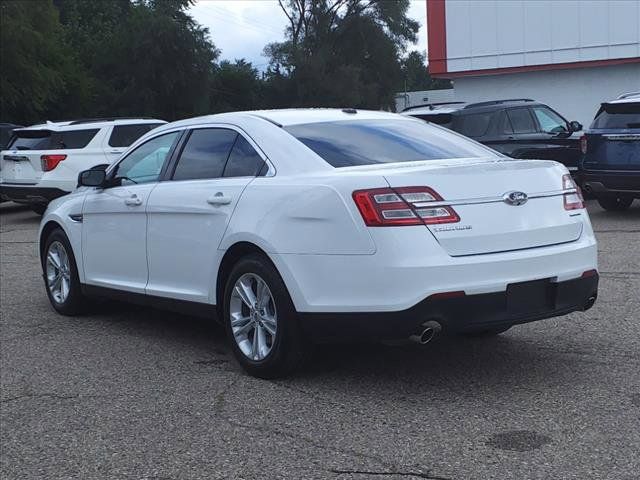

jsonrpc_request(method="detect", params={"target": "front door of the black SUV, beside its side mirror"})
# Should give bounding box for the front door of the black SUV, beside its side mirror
[531,105,581,171]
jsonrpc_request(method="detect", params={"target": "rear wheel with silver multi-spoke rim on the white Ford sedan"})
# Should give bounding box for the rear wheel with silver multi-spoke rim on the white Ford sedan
[223,254,309,379]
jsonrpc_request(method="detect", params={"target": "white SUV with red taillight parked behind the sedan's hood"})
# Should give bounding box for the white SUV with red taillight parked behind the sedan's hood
[0,118,166,214]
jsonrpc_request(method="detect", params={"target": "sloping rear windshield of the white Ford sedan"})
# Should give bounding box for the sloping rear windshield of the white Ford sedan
[285,119,491,168]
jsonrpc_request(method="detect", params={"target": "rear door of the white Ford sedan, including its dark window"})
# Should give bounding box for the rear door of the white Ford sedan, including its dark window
[146,126,265,303]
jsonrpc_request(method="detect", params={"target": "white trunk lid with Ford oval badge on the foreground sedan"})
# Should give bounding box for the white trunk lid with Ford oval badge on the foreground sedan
[381,159,583,256]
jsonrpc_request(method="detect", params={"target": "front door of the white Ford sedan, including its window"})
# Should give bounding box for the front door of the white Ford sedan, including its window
[82,131,181,293]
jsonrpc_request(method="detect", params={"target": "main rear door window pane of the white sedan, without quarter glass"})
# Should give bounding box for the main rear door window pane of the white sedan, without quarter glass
[173,128,238,180]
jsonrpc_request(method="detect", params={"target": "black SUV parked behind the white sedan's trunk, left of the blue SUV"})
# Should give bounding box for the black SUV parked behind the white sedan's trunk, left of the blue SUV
[402,98,582,173]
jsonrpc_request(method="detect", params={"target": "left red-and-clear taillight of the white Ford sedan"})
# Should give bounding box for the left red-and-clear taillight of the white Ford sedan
[353,187,460,227]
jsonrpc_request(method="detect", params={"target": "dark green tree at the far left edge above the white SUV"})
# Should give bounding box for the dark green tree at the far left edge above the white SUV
[0,0,87,124]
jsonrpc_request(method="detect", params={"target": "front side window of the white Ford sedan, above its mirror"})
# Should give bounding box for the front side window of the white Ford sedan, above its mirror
[114,132,180,185]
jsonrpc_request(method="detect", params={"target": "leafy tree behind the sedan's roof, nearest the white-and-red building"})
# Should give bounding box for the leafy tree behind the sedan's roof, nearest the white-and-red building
[265,0,418,108]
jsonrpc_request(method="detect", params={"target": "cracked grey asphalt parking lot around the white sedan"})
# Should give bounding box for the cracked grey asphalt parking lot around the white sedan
[0,202,640,480]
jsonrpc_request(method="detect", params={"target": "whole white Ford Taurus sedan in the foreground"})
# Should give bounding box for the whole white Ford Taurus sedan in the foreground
[39,109,598,377]
